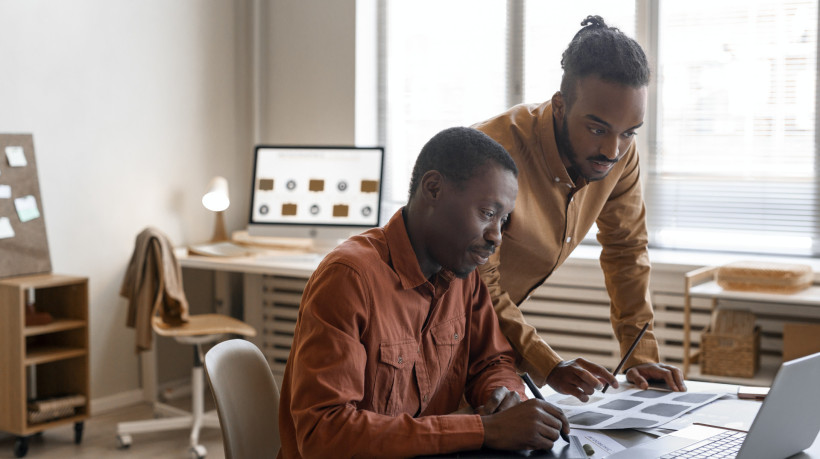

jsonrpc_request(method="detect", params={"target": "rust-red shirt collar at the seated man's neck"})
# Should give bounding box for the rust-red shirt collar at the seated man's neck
[384,207,455,289]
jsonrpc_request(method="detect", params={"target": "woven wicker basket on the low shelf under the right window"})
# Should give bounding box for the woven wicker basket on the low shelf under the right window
[700,310,760,378]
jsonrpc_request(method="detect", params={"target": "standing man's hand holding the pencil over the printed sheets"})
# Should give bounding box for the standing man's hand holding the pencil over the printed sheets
[547,357,618,402]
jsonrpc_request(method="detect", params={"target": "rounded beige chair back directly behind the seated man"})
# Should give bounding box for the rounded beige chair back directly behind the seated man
[205,339,281,459]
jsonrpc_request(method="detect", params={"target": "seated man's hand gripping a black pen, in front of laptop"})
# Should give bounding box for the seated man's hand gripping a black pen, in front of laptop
[481,399,569,450]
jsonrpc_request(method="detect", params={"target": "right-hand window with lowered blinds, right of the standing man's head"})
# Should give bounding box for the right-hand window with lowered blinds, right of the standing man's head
[646,0,818,255]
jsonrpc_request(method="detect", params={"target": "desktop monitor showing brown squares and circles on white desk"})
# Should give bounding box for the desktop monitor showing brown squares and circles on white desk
[248,145,384,251]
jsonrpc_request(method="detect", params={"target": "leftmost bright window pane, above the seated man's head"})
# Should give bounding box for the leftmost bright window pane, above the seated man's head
[381,0,507,210]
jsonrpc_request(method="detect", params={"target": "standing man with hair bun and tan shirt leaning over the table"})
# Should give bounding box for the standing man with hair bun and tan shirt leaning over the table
[475,16,686,401]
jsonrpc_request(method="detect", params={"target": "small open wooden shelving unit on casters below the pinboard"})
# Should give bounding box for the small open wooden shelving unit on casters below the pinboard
[0,274,90,457]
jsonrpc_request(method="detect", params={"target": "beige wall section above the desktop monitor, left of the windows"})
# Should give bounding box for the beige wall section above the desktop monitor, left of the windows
[258,0,356,145]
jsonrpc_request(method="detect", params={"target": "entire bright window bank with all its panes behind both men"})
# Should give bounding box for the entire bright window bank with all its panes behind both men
[380,0,820,255]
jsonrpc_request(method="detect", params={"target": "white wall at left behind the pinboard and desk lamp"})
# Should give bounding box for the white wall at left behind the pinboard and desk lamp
[0,0,253,398]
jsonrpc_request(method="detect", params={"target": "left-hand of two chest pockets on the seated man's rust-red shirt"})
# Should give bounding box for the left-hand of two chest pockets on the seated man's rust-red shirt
[373,340,419,416]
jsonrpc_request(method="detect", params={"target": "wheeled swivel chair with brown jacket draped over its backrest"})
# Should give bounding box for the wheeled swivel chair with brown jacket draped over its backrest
[117,228,256,459]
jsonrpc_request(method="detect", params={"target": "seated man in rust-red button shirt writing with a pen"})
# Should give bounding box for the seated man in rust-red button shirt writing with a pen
[279,128,569,458]
